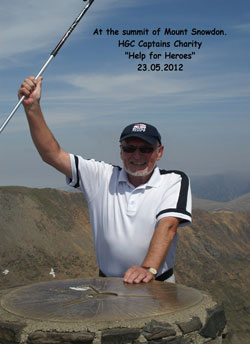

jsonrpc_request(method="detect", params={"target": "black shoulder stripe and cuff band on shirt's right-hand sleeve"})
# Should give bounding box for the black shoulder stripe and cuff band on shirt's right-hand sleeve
[156,170,191,221]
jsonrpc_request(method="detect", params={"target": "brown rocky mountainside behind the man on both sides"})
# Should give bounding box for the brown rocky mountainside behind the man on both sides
[0,187,250,344]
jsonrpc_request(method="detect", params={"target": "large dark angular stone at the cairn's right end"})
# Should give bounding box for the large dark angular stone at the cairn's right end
[199,305,227,339]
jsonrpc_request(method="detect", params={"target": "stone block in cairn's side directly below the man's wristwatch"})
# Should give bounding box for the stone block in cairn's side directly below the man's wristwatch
[143,320,176,340]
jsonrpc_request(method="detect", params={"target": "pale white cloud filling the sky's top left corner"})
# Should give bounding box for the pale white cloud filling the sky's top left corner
[0,0,89,58]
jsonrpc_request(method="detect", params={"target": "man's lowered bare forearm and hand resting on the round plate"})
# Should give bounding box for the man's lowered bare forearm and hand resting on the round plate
[124,217,179,283]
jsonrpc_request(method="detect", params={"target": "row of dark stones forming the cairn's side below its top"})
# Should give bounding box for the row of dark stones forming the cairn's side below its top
[0,305,226,344]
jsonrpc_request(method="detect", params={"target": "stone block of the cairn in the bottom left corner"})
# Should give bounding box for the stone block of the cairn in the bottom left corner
[0,322,26,344]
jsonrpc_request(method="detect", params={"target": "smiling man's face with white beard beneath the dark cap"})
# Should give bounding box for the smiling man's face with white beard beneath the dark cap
[120,137,163,177]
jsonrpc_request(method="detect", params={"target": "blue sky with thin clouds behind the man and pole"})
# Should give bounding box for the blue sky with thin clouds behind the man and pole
[0,0,250,188]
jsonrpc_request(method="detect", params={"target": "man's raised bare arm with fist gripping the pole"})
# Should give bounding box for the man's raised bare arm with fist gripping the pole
[18,76,72,178]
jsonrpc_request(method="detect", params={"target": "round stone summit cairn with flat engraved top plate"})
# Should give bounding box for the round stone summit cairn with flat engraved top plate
[0,278,226,344]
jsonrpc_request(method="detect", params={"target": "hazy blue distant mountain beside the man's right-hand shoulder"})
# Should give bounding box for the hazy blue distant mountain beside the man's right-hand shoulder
[190,173,250,202]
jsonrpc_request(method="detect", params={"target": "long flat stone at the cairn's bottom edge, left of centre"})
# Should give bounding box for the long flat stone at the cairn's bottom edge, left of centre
[27,331,95,344]
